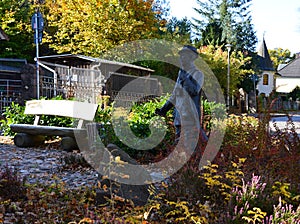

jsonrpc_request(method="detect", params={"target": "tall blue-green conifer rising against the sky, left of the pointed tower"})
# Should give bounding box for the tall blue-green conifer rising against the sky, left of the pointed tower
[193,0,257,52]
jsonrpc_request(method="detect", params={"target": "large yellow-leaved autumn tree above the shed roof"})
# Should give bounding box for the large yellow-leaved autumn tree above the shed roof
[45,0,161,57]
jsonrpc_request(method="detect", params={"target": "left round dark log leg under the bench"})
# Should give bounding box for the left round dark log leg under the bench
[14,133,45,147]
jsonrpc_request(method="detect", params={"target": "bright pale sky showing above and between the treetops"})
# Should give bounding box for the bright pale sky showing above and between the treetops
[170,0,300,53]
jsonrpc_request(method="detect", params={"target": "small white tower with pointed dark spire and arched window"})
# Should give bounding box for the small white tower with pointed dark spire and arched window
[257,39,275,97]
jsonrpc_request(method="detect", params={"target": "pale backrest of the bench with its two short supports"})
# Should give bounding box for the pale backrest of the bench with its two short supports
[24,100,98,128]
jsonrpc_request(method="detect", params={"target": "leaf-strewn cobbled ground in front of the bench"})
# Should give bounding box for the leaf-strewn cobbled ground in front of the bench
[0,136,98,188]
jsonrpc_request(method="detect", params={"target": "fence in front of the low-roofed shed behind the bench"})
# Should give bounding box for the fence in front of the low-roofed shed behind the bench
[40,63,159,106]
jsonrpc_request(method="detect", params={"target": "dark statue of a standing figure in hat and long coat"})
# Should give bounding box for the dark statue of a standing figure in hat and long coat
[156,46,207,143]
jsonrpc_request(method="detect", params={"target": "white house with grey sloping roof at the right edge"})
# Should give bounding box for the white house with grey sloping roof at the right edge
[276,57,300,94]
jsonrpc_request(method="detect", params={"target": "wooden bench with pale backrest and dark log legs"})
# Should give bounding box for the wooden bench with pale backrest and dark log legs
[10,100,98,151]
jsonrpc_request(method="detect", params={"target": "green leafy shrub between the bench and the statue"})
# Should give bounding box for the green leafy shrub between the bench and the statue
[96,97,174,159]
